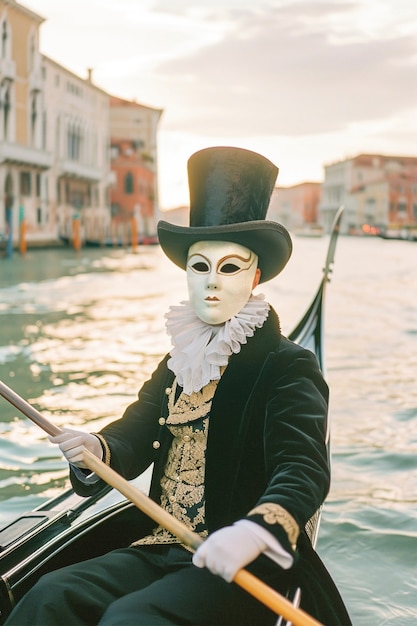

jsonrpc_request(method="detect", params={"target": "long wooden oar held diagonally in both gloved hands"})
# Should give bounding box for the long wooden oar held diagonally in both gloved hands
[0,381,322,626]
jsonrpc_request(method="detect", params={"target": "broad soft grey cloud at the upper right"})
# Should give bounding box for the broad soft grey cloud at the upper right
[154,3,417,136]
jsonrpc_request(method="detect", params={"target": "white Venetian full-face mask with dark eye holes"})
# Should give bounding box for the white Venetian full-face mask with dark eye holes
[187,241,260,324]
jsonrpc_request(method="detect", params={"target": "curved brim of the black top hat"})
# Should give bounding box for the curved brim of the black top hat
[158,220,292,283]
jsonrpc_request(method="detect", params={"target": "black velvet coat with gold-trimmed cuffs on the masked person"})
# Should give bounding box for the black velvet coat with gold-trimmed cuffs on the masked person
[71,310,349,624]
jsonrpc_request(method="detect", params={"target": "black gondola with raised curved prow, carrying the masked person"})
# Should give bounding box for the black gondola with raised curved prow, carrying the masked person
[0,209,343,624]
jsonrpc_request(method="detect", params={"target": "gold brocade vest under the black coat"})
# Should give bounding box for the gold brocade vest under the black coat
[132,372,219,546]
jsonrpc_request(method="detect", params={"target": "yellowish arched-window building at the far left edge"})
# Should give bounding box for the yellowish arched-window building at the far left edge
[0,0,54,249]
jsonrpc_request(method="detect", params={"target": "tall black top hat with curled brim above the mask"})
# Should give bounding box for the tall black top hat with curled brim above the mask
[158,147,292,282]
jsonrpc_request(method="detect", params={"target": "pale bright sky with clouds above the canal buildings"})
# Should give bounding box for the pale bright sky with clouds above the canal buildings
[20,0,417,209]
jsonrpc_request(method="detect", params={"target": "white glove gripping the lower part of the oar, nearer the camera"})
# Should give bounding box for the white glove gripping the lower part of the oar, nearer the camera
[193,522,267,583]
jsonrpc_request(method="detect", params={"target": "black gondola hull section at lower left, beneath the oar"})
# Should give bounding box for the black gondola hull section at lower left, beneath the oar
[0,490,152,624]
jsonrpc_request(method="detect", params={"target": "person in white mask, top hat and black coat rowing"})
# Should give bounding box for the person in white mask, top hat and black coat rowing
[6,147,350,626]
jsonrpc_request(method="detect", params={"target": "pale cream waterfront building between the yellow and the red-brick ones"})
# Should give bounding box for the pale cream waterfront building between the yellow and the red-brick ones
[43,56,111,243]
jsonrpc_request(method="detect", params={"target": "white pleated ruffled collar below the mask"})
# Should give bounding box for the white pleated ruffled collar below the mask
[165,294,270,395]
